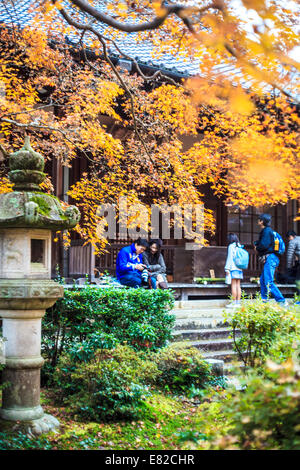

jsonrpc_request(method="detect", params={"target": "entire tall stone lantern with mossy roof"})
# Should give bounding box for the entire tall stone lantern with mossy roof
[0,137,80,434]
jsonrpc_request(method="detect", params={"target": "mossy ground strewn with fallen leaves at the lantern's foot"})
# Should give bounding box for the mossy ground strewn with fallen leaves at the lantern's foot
[0,390,224,450]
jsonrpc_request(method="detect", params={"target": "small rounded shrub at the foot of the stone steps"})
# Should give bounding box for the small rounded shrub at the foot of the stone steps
[153,342,211,395]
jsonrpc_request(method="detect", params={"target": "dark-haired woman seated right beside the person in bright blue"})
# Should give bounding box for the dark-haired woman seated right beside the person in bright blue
[143,239,168,289]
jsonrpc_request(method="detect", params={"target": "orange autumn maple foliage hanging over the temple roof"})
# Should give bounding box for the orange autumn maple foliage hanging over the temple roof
[0,0,299,251]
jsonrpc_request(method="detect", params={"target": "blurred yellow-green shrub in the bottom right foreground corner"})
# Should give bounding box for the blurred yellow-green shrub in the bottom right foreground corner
[222,358,300,450]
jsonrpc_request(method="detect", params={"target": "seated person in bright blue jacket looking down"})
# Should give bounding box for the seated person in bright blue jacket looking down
[116,238,156,289]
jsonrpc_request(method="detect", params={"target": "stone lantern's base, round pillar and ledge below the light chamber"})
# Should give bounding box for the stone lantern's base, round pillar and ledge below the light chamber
[0,279,63,435]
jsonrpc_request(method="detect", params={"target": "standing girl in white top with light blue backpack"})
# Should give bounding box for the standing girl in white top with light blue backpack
[224,233,243,308]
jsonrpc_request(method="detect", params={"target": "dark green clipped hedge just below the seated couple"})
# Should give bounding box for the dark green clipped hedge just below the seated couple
[42,285,175,378]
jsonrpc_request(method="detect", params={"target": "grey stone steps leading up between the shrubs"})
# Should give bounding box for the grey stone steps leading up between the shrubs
[172,299,243,374]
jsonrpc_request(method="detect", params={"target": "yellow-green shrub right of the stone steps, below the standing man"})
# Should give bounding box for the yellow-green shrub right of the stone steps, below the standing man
[225,299,299,367]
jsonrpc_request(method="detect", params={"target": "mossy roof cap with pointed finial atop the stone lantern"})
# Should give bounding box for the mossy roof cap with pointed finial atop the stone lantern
[0,137,80,231]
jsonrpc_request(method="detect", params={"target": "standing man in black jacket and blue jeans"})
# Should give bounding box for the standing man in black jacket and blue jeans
[254,214,287,306]
